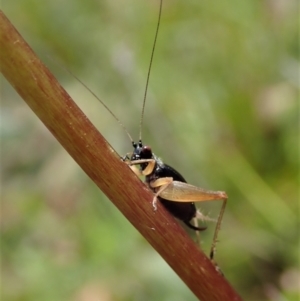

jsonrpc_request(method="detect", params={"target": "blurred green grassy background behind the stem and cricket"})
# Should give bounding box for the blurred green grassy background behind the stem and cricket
[1,0,300,301]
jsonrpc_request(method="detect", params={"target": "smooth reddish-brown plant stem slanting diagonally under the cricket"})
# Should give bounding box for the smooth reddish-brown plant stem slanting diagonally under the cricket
[0,11,241,301]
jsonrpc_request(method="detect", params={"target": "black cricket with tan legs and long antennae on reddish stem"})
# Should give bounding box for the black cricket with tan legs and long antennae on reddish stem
[81,0,227,270]
